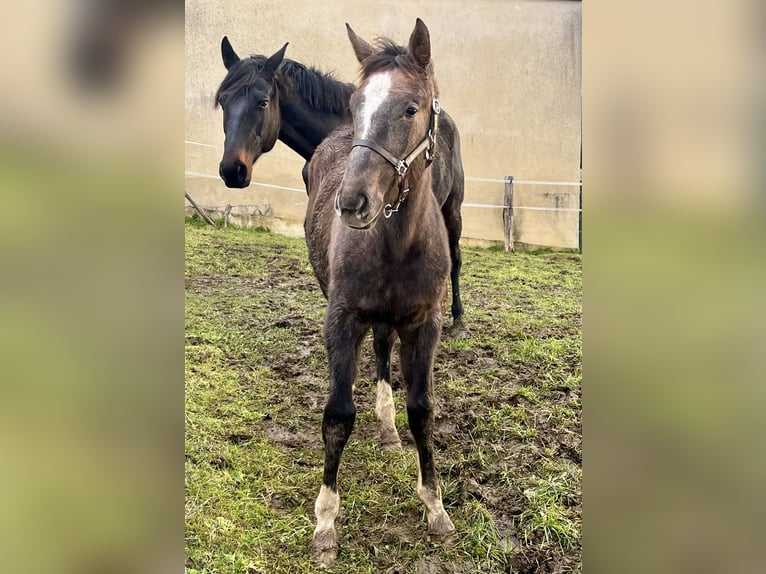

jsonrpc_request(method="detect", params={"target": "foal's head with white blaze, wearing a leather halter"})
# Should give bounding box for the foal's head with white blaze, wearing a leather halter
[335,19,438,229]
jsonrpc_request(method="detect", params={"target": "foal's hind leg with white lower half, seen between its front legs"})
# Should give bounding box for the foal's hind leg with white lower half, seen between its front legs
[372,323,402,451]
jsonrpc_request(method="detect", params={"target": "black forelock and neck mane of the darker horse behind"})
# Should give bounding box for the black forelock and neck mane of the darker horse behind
[215,55,354,114]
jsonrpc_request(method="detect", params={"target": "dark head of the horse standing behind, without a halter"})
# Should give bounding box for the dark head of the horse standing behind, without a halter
[215,36,287,191]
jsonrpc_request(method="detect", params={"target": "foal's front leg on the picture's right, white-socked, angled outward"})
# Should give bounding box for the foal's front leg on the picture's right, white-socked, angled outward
[399,316,455,538]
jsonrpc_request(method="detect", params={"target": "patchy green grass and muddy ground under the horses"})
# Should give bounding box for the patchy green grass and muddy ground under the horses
[185,223,582,574]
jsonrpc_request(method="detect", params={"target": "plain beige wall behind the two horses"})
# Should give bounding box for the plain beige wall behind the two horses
[185,0,582,248]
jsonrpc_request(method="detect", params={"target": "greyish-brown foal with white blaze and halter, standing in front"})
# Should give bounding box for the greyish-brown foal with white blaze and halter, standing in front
[305,19,455,566]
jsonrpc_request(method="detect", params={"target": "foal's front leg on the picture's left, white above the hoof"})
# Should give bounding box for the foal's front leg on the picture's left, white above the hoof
[311,306,367,567]
